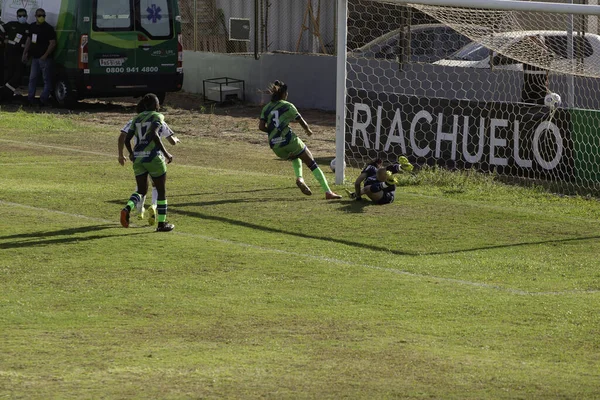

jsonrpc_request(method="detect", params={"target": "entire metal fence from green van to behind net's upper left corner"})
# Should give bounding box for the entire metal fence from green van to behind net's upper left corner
[179,0,440,54]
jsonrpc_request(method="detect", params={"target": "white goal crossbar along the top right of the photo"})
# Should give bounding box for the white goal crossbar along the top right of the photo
[386,0,600,15]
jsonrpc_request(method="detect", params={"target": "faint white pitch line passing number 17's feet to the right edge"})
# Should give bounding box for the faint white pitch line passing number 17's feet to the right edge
[0,200,600,296]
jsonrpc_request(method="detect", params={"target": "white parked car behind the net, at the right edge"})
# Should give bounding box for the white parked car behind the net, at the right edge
[433,31,600,75]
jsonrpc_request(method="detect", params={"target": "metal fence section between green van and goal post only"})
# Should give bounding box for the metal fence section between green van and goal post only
[179,0,336,54]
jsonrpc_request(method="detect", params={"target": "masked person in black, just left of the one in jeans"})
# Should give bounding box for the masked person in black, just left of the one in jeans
[2,8,29,98]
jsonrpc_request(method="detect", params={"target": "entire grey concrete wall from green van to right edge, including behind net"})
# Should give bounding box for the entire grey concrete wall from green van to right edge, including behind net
[183,51,600,111]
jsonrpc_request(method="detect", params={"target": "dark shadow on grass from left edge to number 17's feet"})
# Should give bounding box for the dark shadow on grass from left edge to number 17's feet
[0,225,148,249]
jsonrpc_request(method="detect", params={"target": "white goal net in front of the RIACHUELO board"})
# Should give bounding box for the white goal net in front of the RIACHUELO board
[336,0,600,195]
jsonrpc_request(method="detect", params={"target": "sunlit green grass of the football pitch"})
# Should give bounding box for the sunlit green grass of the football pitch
[0,108,600,399]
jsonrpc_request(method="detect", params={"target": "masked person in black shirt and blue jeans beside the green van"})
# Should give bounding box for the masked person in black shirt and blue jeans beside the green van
[23,8,56,105]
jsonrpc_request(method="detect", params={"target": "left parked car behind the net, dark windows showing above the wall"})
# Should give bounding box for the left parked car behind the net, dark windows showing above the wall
[348,24,471,63]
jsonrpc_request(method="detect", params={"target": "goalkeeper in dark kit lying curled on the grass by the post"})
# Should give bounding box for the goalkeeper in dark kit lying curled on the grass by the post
[348,156,413,205]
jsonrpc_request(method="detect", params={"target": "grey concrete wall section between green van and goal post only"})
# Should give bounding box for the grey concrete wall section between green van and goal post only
[183,51,336,111]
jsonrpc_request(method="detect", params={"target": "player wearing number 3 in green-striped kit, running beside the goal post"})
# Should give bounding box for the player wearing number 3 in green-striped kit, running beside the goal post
[258,81,342,200]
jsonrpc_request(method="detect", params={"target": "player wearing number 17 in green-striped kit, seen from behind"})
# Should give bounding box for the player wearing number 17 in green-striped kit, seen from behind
[121,93,175,232]
